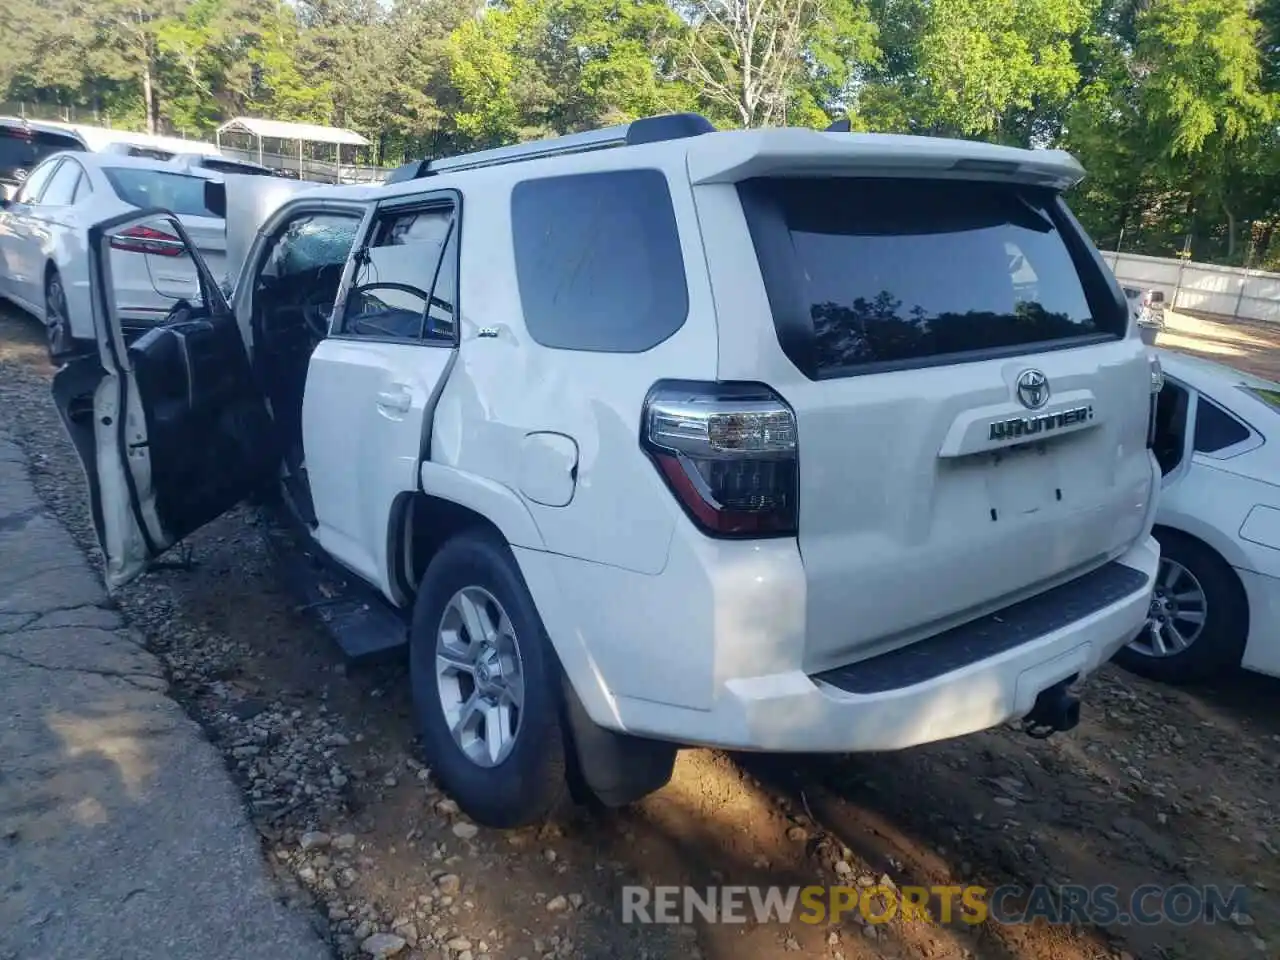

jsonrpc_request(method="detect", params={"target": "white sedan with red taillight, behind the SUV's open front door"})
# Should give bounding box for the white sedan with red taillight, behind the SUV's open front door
[0,152,227,355]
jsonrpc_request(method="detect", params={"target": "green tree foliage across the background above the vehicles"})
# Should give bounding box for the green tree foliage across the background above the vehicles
[0,0,1280,266]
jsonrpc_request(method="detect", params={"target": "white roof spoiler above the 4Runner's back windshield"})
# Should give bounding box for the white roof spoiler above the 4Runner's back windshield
[689,129,1084,191]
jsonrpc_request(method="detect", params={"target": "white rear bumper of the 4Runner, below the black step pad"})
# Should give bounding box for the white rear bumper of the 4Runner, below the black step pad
[599,538,1160,753]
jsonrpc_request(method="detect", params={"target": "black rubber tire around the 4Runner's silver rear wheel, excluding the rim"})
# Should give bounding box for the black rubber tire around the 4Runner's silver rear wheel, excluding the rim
[410,529,568,828]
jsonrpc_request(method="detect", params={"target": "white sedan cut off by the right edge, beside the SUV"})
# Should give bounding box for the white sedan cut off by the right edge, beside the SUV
[1116,349,1280,682]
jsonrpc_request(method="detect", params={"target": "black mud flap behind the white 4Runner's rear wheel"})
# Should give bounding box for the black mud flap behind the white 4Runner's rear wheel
[559,669,678,808]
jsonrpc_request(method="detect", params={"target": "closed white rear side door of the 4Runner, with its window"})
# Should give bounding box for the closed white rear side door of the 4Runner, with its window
[302,191,461,603]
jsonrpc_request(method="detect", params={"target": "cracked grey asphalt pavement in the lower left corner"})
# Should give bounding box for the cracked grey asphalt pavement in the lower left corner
[0,434,330,960]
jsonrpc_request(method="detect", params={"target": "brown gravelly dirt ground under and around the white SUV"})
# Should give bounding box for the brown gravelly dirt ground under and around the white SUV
[0,310,1280,960]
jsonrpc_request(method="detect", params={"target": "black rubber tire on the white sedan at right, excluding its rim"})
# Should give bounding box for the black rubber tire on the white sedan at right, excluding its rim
[1115,527,1249,684]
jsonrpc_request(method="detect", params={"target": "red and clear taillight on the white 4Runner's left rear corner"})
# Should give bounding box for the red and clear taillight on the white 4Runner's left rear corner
[640,380,799,538]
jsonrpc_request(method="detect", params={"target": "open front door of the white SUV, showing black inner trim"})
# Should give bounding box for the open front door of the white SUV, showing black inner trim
[54,210,279,588]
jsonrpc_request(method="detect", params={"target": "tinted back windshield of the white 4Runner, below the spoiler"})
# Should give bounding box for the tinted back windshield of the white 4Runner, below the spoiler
[740,178,1128,376]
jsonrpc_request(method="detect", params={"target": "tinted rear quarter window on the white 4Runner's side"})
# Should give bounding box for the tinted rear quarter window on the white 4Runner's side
[511,170,689,353]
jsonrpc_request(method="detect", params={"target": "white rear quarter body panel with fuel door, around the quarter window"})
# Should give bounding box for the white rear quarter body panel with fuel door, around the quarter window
[422,145,727,722]
